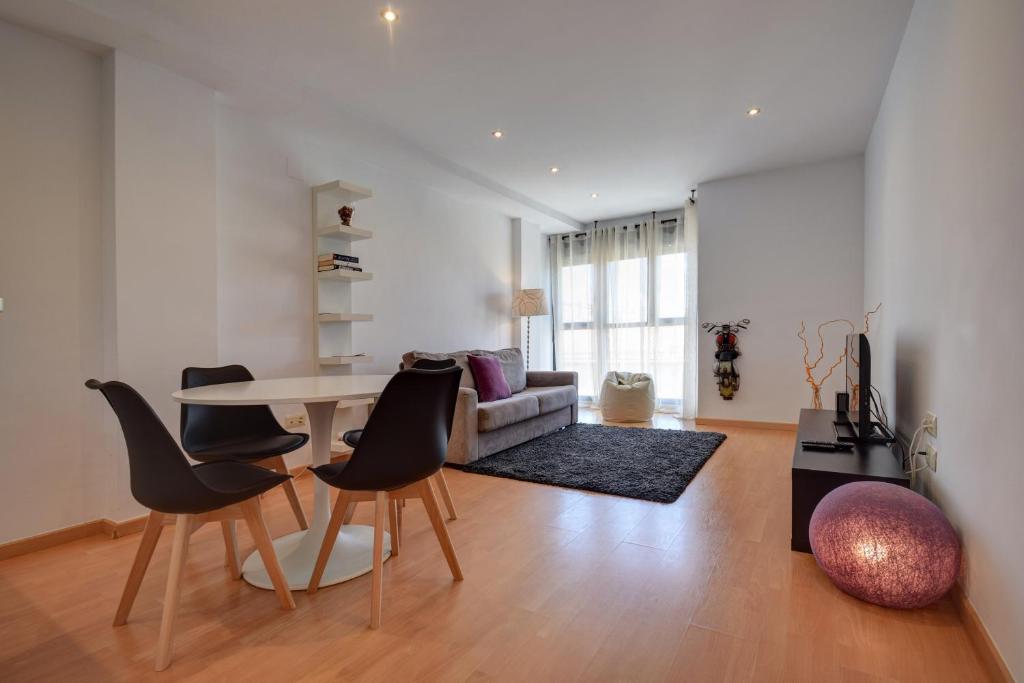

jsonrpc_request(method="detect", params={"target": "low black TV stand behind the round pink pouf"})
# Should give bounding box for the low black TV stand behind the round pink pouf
[790,409,910,553]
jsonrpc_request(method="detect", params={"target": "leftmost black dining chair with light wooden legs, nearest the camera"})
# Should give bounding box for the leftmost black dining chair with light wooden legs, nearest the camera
[85,380,295,671]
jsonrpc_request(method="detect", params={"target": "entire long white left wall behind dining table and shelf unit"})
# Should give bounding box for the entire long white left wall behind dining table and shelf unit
[0,24,528,542]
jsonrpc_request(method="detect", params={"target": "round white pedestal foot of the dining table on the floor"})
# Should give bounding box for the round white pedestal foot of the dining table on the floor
[242,524,391,591]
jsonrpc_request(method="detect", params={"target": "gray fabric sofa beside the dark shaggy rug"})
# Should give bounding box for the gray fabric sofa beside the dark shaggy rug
[401,348,579,465]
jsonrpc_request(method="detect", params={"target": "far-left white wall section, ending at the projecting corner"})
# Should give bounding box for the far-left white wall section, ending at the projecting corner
[0,23,105,543]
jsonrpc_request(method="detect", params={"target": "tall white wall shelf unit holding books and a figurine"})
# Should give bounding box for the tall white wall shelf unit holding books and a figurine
[311,180,374,385]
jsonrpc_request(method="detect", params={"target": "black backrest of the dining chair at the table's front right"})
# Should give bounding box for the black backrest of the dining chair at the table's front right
[340,368,462,490]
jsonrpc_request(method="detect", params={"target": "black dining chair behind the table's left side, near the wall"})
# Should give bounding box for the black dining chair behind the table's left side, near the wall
[181,365,309,532]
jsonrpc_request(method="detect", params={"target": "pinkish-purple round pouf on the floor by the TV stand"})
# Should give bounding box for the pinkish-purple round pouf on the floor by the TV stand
[810,481,961,609]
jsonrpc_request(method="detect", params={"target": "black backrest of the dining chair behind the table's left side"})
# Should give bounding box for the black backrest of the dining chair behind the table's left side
[181,366,288,453]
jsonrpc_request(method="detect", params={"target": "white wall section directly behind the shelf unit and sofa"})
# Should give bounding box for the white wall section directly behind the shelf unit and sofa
[217,103,512,464]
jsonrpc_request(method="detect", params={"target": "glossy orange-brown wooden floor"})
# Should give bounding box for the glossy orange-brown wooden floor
[0,414,984,682]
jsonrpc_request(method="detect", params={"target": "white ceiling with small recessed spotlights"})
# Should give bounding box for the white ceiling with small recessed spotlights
[0,0,912,221]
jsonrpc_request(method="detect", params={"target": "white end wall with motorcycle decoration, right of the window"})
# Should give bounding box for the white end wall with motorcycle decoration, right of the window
[697,157,873,423]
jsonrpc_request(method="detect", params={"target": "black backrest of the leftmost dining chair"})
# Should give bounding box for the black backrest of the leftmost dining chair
[85,380,210,514]
